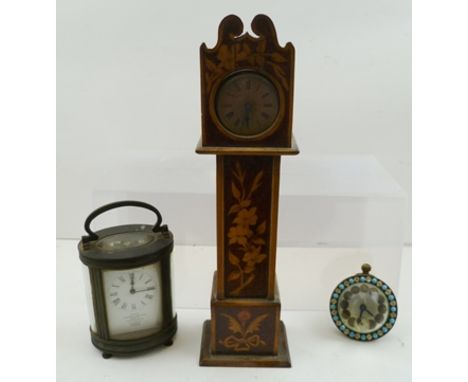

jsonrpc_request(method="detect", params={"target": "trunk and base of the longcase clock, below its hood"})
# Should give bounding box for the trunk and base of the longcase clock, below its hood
[200,155,291,367]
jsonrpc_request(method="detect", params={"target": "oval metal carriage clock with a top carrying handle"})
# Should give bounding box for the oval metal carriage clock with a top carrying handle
[78,201,177,358]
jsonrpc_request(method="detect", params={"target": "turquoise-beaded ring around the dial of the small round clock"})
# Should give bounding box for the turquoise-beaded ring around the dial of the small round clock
[329,273,398,342]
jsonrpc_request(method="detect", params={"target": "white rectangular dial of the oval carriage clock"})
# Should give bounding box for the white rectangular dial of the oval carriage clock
[102,262,163,339]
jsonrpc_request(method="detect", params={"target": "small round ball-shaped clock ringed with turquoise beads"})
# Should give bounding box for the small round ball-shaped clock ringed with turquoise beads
[330,264,398,341]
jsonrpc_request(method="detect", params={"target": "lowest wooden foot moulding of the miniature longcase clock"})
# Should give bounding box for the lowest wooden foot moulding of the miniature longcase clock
[200,320,291,367]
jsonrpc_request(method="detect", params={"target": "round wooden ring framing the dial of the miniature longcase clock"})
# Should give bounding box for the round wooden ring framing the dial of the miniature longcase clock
[209,69,285,141]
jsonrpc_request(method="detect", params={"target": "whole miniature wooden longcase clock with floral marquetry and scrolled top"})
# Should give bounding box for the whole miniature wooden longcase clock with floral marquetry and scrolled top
[196,15,299,367]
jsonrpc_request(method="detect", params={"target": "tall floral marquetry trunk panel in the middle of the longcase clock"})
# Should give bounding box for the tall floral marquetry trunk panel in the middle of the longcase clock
[220,156,279,297]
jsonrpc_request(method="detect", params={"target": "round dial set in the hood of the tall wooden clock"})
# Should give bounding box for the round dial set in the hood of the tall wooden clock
[216,72,279,137]
